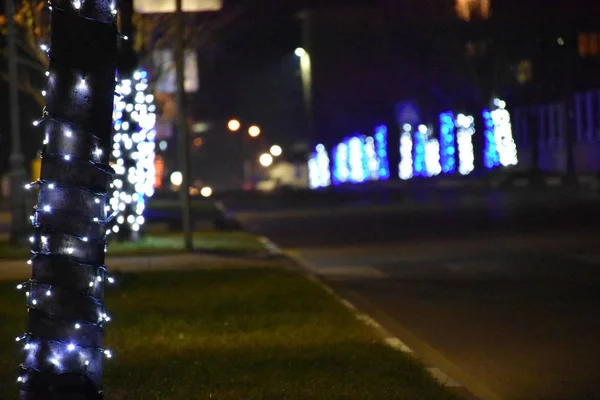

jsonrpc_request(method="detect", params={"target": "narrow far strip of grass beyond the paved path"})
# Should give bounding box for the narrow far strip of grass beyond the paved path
[0,231,266,259]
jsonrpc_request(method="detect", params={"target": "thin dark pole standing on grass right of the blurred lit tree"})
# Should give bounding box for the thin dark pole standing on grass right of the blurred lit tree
[175,0,194,251]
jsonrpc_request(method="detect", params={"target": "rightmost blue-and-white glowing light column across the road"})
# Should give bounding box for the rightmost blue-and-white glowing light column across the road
[483,99,519,168]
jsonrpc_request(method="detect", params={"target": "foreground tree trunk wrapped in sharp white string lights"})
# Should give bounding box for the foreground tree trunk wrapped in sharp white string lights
[16,0,117,400]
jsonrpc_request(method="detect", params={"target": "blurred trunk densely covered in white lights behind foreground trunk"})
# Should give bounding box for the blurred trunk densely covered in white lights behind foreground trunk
[110,71,156,239]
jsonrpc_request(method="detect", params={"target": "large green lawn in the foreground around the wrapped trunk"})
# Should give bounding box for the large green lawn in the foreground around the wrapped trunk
[0,268,455,400]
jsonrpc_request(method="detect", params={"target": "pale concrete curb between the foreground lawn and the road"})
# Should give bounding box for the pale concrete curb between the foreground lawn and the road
[288,255,480,400]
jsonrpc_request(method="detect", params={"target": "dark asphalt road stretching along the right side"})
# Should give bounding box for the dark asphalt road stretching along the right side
[239,193,600,400]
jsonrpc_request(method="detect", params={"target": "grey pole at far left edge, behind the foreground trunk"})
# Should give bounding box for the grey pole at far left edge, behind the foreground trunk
[4,0,27,244]
